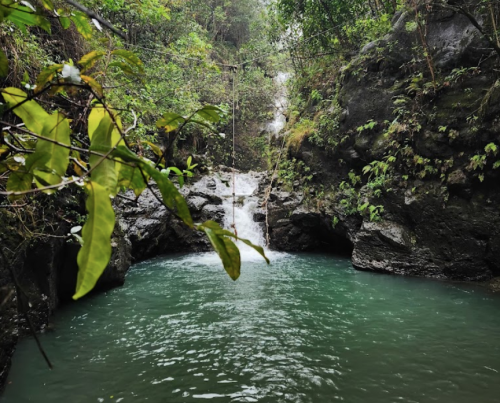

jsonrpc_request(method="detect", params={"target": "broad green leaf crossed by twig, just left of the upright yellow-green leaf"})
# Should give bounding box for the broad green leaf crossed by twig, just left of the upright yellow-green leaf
[33,112,71,193]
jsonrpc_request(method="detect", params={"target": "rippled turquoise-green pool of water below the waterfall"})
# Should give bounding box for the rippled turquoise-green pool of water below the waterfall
[1,254,500,403]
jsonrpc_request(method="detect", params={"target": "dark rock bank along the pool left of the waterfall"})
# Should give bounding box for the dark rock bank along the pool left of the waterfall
[0,177,224,391]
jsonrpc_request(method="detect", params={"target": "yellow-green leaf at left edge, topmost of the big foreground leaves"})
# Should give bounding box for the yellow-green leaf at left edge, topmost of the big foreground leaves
[2,87,49,134]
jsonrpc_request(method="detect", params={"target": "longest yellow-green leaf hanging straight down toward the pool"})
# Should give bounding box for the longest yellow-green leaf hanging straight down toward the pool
[73,181,115,299]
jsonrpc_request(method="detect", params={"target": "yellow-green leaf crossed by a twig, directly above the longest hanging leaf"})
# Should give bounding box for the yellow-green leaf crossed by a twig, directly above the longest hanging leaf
[89,114,118,196]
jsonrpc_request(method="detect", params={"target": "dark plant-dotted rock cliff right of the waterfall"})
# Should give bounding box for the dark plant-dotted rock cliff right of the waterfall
[268,7,500,281]
